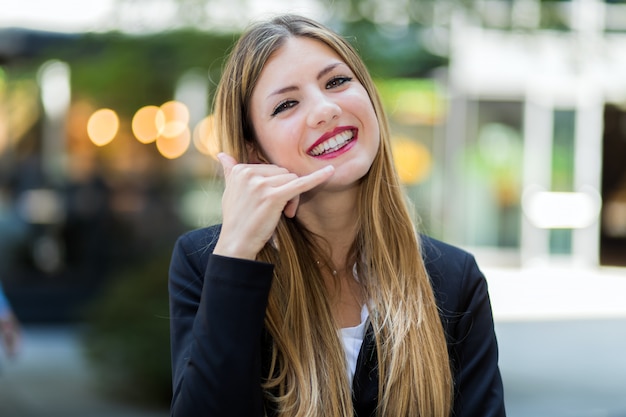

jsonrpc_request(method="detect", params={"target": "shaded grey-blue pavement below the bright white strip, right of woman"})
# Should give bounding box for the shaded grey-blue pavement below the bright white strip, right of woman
[496,319,626,417]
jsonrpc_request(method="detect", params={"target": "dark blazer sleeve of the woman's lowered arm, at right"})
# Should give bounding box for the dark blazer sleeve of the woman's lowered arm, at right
[427,237,506,417]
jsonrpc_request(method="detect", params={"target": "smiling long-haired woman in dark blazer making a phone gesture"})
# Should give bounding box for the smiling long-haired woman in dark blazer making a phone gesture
[170,15,504,417]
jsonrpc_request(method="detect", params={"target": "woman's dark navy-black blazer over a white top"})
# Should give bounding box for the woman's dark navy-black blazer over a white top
[169,226,505,417]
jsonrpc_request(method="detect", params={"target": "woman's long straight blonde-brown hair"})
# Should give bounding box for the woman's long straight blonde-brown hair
[214,15,453,417]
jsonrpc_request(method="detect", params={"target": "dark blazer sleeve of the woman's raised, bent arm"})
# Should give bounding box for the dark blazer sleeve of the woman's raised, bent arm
[169,231,273,417]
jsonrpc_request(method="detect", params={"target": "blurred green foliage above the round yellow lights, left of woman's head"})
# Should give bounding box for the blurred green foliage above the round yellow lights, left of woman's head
[43,30,236,117]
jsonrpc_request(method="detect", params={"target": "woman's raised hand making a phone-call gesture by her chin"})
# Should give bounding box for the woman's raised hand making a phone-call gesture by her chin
[213,153,334,259]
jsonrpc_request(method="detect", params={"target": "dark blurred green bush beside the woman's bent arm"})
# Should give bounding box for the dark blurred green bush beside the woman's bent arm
[83,254,171,407]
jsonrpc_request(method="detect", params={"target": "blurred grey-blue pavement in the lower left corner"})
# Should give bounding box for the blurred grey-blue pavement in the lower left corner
[0,327,169,417]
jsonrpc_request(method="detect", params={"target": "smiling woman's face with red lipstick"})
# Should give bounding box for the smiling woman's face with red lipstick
[250,37,380,186]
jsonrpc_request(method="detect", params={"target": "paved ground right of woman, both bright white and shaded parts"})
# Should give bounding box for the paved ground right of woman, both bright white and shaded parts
[484,266,626,417]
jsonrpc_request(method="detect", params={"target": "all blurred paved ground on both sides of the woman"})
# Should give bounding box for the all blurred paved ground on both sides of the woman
[0,268,626,417]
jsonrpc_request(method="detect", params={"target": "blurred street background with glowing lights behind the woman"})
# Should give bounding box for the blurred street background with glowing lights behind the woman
[0,0,626,417]
